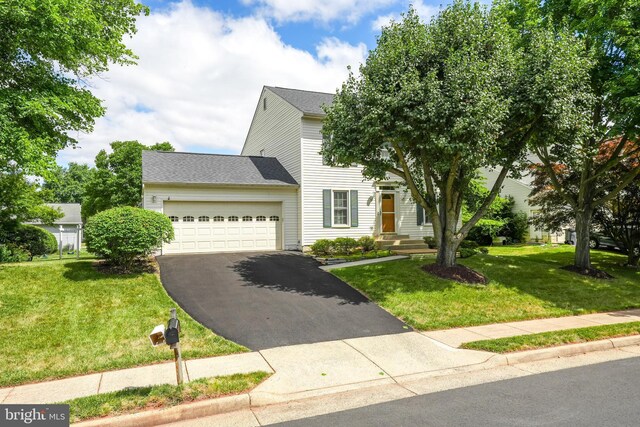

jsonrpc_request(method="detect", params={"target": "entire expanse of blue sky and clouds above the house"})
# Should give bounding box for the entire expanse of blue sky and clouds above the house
[58,0,450,165]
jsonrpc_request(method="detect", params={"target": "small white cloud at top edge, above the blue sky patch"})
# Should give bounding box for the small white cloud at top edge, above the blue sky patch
[243,0,397,23]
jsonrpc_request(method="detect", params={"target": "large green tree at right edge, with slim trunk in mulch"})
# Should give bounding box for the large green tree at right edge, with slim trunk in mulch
[498,0,640,271]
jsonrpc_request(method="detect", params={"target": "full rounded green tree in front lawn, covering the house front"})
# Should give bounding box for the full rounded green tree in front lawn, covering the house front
[322,1,587,267]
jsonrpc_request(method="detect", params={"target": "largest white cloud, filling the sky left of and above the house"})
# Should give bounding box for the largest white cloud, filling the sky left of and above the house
[59,1,366,163]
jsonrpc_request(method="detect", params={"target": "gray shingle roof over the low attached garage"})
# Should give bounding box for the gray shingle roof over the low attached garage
[142,151,298,186]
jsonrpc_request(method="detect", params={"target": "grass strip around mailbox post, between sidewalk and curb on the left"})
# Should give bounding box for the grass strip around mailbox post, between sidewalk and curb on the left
[62,371,271,423]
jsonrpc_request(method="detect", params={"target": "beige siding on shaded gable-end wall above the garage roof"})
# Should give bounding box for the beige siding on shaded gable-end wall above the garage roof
[241,88,302,183]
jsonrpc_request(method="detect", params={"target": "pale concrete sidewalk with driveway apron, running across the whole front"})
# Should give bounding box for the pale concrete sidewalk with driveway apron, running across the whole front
[0,310,640,406]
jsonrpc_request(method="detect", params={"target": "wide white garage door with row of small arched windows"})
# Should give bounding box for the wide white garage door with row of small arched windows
[162,202,282,254]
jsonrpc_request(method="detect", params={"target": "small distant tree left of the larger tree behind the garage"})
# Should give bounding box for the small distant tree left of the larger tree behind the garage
[42,162,91,203]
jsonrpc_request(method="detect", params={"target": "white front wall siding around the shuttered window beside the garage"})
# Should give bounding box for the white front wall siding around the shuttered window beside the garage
[300,118,376,246]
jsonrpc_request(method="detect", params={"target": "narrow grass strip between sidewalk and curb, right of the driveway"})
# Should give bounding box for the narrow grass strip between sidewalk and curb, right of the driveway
[461,322,640,353]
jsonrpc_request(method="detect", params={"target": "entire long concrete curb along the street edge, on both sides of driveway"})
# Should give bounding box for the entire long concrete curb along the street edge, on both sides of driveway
[73,335,640,427]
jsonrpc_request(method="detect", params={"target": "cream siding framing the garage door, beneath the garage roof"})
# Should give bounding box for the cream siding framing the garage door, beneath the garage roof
[143,184,299,250]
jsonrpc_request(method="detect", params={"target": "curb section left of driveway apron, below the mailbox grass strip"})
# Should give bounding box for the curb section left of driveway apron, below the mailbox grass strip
[73,393,251,427]
